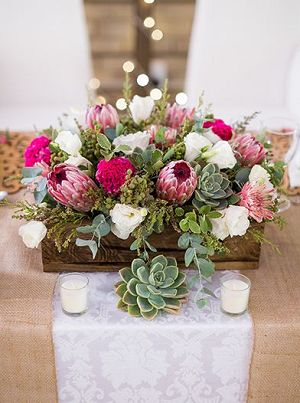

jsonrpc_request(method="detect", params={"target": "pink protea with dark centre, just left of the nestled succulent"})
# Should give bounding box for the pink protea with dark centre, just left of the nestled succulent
[156,160,197,204]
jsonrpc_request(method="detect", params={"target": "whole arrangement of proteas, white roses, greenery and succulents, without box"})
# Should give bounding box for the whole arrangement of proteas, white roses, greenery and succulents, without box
[6,78,283,319]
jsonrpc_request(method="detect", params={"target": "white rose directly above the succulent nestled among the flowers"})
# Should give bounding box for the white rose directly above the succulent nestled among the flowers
[204,140,236,169]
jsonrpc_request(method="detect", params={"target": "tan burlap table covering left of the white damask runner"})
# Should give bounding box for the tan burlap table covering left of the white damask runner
[0,200,57,403]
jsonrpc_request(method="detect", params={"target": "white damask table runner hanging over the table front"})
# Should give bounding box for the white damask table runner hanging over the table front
[53,272,253,403]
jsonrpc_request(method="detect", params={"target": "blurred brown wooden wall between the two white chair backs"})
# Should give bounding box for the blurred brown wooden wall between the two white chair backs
[85,0,195,102]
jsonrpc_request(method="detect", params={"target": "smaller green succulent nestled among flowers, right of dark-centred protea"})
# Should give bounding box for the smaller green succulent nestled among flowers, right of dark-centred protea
[193,163,233,209]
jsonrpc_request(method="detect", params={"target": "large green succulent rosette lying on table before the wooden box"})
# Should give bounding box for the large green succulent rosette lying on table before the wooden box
[115,255,188,320]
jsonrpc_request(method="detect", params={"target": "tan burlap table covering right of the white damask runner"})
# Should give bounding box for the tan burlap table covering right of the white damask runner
[243,206,300,403]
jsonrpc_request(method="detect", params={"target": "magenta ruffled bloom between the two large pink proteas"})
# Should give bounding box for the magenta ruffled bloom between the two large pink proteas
[96,157,135,194]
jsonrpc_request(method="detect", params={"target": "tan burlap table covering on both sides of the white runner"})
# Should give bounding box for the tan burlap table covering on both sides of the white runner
[0,193,300,403]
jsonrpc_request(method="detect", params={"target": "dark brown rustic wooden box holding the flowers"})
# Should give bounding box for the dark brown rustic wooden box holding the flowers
[42,224,263,272]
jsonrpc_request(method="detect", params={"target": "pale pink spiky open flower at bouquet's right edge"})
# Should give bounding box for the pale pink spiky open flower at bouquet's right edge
[239,182,275,222]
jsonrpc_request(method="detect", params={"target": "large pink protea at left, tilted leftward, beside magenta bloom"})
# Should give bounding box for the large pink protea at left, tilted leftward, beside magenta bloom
[47,164,98,212]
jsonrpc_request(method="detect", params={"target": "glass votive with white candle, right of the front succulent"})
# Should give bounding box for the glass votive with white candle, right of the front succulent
[221,273,251,315]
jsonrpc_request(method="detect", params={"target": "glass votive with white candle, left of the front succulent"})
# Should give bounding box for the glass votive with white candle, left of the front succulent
[59,273,89,316]
